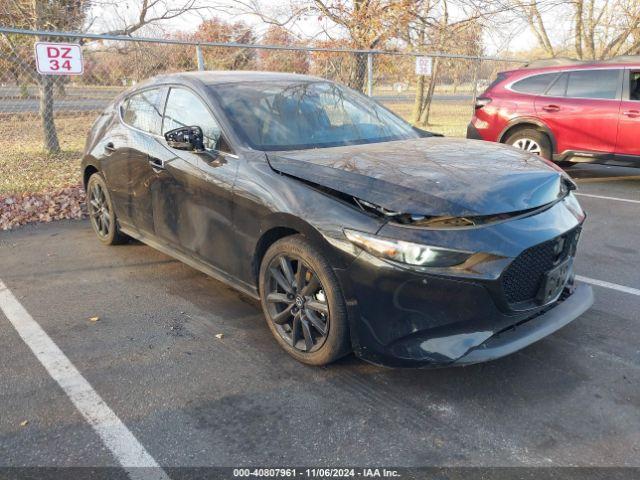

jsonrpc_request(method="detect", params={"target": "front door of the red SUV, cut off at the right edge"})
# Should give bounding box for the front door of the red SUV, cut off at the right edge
[616,68,640,161]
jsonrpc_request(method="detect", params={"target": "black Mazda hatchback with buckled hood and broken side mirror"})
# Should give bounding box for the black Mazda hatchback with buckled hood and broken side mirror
[82,72,593,367]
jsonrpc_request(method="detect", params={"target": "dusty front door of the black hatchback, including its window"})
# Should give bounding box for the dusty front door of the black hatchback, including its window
[153,87,238,272]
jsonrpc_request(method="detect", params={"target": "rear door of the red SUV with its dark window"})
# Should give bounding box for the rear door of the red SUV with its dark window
[535,68,623,153]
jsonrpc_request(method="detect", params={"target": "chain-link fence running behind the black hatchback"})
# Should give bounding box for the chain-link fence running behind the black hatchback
[0,28,518,153]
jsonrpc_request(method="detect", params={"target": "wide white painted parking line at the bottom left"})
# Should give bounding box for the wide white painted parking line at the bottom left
[0,280,169,480]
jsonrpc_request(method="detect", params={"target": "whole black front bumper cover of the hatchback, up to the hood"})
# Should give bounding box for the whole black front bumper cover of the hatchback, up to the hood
[338,188,592,367]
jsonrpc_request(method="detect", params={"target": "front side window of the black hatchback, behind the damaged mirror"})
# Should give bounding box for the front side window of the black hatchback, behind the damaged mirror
[162,88,229,151]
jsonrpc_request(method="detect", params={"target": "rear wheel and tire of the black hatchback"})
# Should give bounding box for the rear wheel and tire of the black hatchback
[87,172,129,245]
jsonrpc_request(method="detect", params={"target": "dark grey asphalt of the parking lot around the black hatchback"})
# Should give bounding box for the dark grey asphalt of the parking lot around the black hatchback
[0,165,640,467]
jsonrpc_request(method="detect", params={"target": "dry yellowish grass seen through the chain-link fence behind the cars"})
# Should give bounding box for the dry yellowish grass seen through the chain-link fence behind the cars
[0,97,471,196]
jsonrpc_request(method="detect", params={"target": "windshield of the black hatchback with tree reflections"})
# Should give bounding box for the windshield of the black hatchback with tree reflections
[212,81,419,150]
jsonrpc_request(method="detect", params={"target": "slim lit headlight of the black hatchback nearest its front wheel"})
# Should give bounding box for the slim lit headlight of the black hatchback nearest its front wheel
[344,229,473,267]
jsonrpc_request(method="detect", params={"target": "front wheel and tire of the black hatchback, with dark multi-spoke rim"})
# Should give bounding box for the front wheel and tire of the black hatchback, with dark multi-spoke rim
[259,235,351,366]
